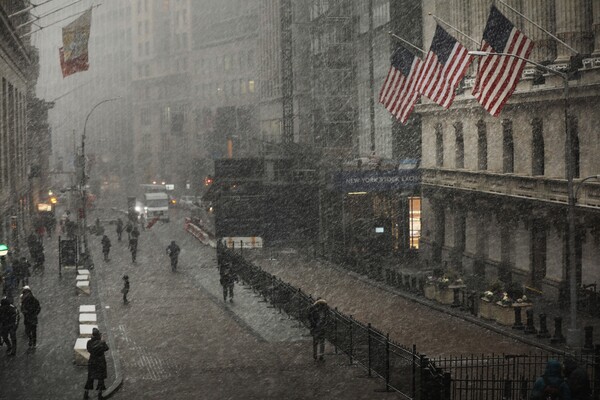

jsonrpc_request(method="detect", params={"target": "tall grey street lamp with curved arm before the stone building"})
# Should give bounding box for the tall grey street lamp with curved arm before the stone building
[469,51,587,348]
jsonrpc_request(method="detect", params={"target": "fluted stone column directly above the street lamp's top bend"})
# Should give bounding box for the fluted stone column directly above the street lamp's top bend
[556,0,597,62]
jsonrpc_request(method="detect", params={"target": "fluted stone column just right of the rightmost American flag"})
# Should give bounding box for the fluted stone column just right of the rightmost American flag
[523,0,556,62]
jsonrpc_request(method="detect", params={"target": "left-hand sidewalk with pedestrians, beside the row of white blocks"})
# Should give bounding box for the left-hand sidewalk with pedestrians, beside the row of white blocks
[0,231,115,400]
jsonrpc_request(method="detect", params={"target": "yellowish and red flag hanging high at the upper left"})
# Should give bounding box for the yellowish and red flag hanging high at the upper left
[59,8,92,78]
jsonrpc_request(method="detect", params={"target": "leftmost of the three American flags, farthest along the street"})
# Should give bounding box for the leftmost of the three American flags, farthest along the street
[379,47,423,124]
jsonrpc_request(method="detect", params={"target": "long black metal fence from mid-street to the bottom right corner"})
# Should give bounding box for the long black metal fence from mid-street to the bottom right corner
[217,244,600,400]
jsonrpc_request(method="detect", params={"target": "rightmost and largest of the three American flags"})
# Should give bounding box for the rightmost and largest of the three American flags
[473,6,533,117]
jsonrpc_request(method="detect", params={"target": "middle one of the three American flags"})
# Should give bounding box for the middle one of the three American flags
[418,25,473,109]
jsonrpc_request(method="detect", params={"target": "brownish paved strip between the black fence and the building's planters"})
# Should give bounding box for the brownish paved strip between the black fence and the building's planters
[244,249,600,357]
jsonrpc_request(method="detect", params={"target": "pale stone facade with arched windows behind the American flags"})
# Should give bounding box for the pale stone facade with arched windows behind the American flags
[416,0,600,299]
